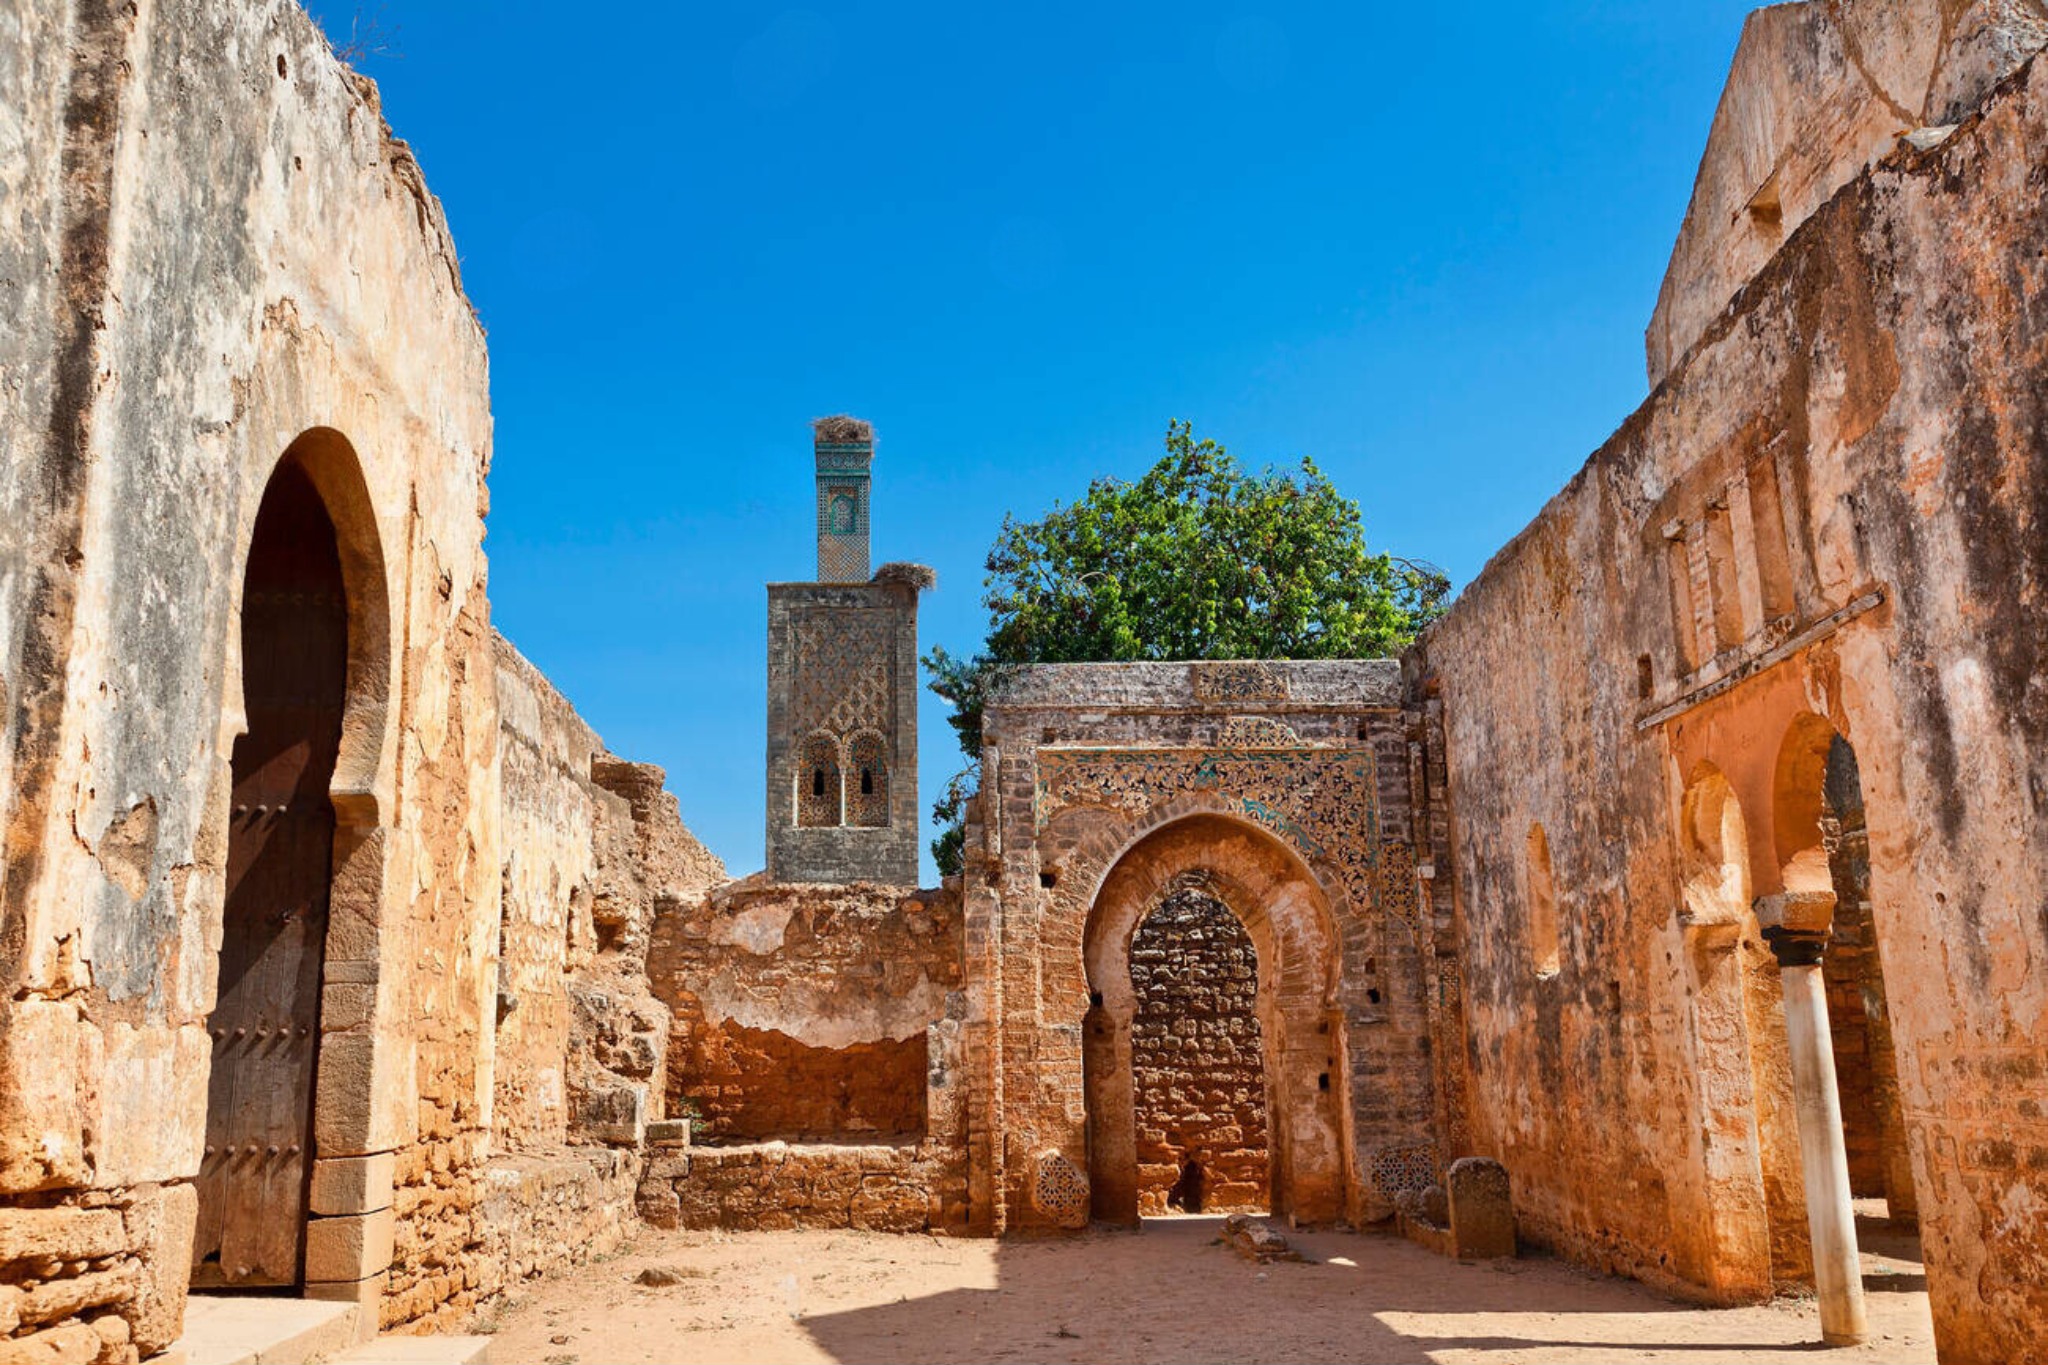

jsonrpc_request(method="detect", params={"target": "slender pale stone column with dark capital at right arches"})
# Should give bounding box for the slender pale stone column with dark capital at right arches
[1757,890,1870,1347]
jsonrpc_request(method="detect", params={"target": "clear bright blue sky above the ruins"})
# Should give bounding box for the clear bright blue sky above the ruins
[315,0,1749,880]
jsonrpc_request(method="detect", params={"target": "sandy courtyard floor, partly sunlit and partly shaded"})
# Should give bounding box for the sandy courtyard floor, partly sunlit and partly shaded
[479,1218,1933,1365]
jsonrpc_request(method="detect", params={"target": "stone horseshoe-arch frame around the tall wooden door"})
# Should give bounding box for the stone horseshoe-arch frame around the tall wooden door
[205,428,414,1332]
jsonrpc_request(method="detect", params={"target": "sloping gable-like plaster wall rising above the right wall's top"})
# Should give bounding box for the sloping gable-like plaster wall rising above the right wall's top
[1645,0,2048,385]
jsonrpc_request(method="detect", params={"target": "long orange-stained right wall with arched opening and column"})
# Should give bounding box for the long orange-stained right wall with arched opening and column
[1425,40,2048,1361]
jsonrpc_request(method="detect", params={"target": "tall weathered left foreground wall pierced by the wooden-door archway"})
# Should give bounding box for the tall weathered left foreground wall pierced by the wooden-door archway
[0,0,498,1359]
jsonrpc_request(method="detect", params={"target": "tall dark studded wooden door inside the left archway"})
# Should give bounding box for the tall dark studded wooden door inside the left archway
[193,460,348,1287]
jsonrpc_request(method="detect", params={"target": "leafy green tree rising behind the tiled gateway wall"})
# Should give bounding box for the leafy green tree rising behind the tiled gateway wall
[924,422,1450,872]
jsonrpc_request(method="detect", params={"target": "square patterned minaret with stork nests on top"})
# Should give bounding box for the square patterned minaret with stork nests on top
[768,417,934,886]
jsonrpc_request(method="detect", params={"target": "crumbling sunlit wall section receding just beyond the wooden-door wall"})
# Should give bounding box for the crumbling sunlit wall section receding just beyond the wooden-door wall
[448,636,725,1322]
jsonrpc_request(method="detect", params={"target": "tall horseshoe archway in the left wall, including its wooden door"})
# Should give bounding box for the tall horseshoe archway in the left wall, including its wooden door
[193,428,401,1287]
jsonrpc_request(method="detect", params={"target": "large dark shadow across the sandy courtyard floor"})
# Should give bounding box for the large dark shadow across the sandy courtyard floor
[803,1218,1929,1365]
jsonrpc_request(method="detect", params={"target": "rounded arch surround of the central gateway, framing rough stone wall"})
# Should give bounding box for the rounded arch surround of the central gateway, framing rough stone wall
[1081,814,1350,1224]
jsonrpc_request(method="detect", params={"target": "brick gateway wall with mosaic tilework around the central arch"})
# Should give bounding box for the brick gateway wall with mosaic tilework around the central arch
[963,661,1464,1232]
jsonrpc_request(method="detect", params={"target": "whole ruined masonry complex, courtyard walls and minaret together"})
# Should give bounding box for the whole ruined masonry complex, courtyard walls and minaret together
[0,0,2048,1365]
